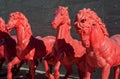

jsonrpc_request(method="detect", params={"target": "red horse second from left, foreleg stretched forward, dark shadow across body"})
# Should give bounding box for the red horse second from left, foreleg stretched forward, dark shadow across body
[7,12,55,79]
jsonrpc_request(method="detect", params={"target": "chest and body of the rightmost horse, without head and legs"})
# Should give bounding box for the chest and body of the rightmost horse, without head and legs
[86,37,120,68]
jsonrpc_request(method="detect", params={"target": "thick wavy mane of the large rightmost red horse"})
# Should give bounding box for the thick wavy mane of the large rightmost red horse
[79,8,109,36]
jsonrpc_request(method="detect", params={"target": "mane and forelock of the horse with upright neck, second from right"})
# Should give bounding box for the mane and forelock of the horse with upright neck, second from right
[55,6,70,25]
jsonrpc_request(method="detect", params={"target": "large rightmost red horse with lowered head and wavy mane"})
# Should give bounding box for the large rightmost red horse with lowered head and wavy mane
[74,9,120,79]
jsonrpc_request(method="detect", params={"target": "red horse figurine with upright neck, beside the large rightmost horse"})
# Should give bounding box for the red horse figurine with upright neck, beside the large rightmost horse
[48,6,86,79]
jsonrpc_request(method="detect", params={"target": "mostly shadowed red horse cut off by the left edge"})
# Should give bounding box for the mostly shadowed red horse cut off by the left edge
[0,18,16,67]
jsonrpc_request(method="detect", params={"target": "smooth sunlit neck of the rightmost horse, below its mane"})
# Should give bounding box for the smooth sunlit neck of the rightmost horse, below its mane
[90,25,107,49]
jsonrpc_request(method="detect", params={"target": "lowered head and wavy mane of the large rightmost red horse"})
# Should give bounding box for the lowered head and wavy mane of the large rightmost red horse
[74,9,108,48]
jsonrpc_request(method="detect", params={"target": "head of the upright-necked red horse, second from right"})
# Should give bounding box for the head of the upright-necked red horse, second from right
[52,6,70,29]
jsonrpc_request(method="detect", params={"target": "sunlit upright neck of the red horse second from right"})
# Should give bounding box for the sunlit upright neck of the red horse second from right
[57,23,72,40]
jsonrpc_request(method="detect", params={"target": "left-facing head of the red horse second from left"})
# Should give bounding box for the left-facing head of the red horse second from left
[7,12,28,30]
